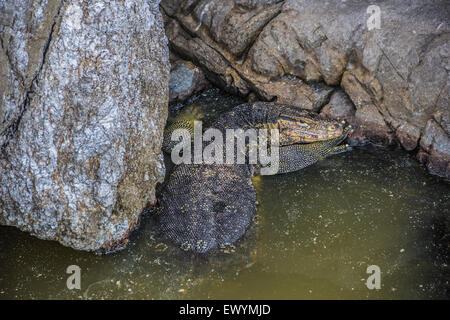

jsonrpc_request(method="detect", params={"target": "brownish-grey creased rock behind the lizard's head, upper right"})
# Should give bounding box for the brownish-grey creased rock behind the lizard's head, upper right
[161,0,450,176]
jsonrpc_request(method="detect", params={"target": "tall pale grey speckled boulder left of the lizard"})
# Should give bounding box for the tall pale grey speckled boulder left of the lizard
[0,0,169,250]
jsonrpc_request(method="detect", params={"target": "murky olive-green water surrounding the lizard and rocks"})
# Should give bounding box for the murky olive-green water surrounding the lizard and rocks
[0,92,450,299]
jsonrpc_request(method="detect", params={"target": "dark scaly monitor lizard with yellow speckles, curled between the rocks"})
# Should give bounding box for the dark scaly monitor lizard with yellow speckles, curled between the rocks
[158,102,350,253]
